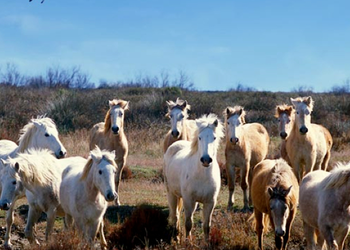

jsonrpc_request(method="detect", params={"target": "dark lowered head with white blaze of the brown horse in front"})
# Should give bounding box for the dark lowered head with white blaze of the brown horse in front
[268,186,292,237]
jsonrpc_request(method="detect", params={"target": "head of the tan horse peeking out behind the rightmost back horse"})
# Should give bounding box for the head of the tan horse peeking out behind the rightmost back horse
[275,104,294,140]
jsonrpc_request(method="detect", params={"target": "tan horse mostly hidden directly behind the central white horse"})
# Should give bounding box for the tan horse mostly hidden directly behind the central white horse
[163,98,196,154]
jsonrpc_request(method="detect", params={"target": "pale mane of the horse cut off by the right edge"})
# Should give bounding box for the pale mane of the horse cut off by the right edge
[324,163,350,189]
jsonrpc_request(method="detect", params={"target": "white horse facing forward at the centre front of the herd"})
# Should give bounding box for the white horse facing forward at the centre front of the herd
[164,114,224,240]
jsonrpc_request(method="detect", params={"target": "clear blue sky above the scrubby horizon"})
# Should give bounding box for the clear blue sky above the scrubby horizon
[0,0,350,92]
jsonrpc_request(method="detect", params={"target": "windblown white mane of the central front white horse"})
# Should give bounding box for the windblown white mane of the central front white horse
[190,114,224,155]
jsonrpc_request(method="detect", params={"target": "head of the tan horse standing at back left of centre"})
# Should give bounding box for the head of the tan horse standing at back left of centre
[108,100,129,135]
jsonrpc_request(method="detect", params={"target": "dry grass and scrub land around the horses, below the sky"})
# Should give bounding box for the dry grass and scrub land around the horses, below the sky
[0,85,350,250]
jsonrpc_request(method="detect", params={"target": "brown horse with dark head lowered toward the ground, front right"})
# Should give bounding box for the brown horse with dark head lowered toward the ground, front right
[251,159,299,250]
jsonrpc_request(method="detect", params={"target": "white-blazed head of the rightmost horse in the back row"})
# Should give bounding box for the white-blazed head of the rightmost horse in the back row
[290,96,314,135]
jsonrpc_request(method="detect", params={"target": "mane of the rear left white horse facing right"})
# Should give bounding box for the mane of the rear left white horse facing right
[18,115,56,153]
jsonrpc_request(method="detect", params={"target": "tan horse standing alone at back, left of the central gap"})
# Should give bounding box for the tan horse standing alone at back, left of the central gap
[90,99,129,205]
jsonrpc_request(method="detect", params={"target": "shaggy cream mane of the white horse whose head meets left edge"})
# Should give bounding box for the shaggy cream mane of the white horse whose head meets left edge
[9,149,60,186]
